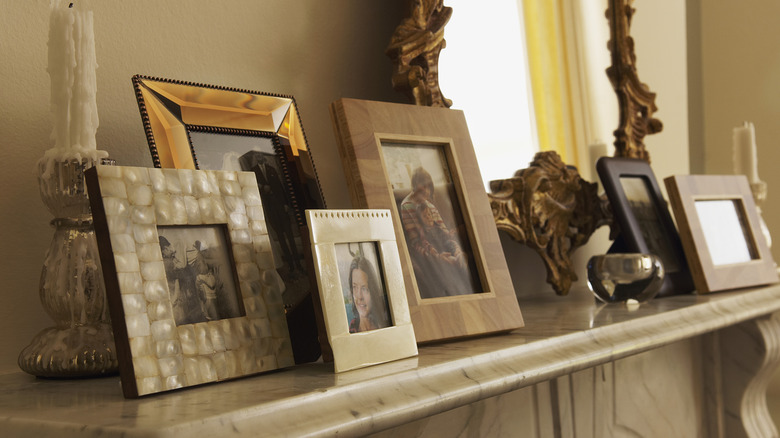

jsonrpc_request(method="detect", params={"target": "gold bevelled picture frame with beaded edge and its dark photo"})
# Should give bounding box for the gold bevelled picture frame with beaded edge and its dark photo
[133,75,325,363]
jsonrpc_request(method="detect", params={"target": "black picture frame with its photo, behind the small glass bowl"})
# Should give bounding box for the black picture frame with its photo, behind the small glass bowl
[596,157,694,297]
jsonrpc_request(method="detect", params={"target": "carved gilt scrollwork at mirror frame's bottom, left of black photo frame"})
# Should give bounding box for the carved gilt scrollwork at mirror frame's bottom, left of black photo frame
[488,151,612,295]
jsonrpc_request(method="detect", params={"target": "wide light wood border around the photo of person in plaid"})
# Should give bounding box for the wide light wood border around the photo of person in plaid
[331,99,523,343]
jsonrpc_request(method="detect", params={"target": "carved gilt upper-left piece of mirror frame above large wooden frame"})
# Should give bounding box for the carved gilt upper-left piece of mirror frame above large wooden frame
[385,0,452,108]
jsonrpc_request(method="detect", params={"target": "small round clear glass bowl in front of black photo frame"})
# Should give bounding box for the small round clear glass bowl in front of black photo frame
[588,253,664,303]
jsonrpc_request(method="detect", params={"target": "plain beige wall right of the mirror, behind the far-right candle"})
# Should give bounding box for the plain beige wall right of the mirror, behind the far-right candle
[689,0,780,260]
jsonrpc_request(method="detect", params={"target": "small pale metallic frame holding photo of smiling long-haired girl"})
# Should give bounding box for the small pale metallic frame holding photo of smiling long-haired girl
[306,210,417,373]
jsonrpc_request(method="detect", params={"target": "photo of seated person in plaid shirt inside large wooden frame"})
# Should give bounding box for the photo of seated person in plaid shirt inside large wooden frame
[381,142,483,299]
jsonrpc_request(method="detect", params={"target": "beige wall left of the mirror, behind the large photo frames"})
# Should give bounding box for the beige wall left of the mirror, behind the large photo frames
[0,0,403,373]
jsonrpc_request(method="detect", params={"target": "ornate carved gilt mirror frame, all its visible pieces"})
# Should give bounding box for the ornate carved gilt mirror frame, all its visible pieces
[386,0,663,295]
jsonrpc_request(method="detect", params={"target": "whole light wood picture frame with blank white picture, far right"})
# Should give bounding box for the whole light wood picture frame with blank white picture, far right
[664,175,778,293]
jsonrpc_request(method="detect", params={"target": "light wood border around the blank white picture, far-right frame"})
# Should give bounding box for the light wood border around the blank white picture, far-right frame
[664,175,778,293]
